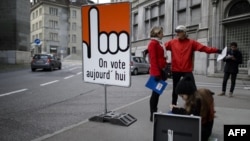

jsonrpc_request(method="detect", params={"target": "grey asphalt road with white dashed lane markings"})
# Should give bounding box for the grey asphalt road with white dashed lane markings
[0,62,152,141]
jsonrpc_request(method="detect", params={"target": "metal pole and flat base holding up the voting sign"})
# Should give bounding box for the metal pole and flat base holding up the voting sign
[89,84,137,126]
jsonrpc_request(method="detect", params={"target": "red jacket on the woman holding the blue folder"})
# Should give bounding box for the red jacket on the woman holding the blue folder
[148,39,167,76]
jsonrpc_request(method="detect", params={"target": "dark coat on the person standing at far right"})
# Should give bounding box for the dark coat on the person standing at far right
[223,49,242,73]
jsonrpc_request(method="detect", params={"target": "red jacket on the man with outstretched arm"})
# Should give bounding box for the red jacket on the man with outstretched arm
[165,38,218,72]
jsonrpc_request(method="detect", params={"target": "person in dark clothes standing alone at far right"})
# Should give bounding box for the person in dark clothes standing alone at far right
[219,42,242,97]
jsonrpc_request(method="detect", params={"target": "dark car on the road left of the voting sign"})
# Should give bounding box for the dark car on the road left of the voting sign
[30,54,62,71]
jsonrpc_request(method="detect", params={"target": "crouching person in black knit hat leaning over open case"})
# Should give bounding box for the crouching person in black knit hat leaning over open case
[170,76,215,141]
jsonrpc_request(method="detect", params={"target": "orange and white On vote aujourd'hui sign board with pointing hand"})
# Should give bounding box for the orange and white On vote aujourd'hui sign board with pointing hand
[82,2,131,87]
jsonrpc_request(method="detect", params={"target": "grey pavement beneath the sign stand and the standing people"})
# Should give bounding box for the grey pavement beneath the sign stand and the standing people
[34,76,250,141]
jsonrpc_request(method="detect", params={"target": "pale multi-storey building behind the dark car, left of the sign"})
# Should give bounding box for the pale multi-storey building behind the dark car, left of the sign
[30,0,87,58]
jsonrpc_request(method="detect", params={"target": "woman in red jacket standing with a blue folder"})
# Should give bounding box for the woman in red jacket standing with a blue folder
[147,26,167,121]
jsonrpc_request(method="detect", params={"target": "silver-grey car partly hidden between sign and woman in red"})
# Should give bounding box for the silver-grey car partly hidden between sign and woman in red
[130,56,150,75]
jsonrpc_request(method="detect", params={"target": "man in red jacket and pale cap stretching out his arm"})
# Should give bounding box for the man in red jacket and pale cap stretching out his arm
[165,25,222,105]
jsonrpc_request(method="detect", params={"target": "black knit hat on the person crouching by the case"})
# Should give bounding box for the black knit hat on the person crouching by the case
[175,76,197,95]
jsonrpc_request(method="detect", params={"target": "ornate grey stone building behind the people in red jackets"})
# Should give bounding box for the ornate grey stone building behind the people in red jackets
[131,0,250,75]
